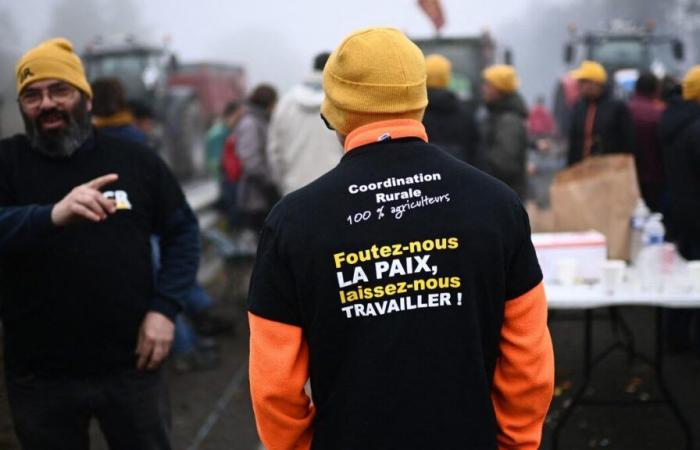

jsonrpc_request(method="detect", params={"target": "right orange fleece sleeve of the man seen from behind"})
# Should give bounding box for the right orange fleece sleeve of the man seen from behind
[491,283,554,450]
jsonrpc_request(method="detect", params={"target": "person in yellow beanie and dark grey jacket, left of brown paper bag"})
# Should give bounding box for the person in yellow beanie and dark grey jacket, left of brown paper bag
[481,65,527,199]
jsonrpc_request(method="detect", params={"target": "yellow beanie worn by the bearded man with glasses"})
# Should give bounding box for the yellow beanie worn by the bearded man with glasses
[15,38,92,98]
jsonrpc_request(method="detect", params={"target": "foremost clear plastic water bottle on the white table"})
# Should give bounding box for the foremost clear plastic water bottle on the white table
[638,213,666,291]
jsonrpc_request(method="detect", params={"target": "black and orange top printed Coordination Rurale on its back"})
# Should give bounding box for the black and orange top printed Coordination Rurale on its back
[249,120,554,450]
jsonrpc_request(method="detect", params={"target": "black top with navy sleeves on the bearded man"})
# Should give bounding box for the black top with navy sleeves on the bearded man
[0,131,199,377]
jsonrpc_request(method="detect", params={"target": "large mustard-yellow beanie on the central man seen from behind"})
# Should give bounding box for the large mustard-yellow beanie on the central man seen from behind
[321,28,428,135]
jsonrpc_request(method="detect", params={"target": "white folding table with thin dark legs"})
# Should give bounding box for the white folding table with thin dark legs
[545,284,700,450]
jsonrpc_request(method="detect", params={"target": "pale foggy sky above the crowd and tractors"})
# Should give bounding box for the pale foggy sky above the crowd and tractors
[0,0,679,134]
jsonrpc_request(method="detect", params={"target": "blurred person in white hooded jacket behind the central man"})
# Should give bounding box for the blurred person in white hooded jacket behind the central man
[267,53,343,195]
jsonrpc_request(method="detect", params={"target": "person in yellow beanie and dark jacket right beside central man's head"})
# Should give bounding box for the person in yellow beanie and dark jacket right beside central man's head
[423,54,479,164]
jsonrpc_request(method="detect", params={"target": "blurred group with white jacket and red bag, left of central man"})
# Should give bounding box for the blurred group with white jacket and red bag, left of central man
[202,53,343,242]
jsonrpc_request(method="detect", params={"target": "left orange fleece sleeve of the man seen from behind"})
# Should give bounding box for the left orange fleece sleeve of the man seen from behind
[248,313,314,450]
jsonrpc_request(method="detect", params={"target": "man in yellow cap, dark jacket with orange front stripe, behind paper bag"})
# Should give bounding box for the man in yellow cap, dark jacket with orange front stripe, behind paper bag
[568,60,634,165]
